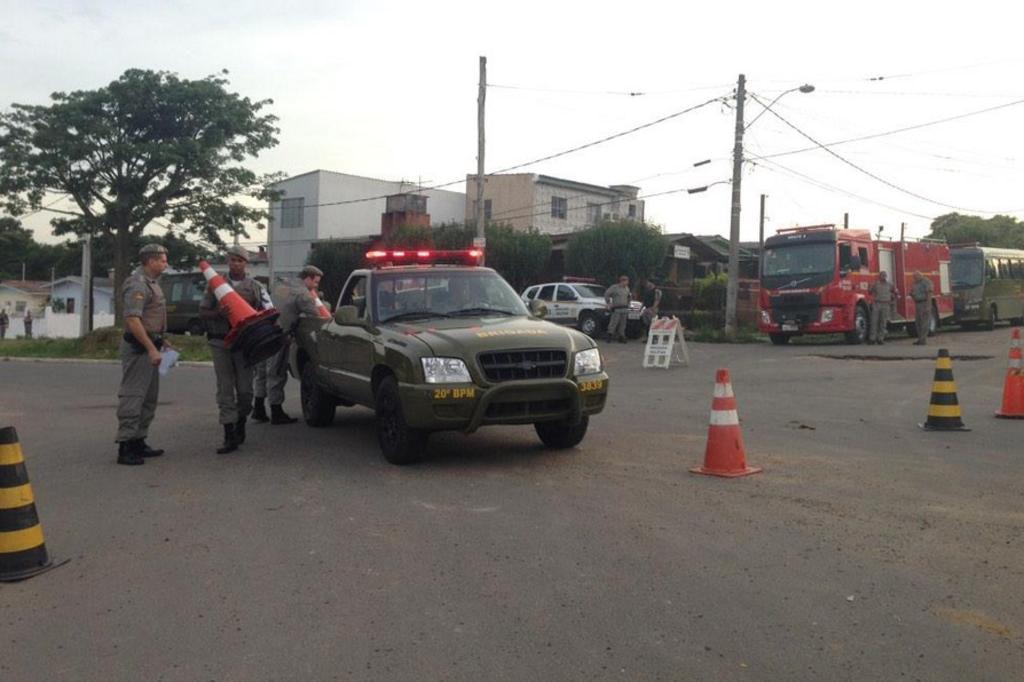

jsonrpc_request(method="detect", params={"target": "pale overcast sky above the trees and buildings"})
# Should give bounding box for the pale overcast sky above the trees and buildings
[0,0,1024,241]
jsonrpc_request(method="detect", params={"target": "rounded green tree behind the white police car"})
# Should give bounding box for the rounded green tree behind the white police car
[565,220,669,285]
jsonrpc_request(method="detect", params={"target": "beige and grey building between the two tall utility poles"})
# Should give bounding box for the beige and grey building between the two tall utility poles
[466,173,644,235]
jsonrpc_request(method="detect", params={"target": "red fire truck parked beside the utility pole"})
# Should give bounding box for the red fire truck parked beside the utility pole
[758,225,953,344]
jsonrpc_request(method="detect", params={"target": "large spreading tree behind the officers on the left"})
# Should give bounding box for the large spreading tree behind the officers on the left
[0,69,278,316]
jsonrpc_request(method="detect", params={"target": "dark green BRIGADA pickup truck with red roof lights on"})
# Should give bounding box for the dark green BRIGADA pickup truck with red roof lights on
[290,252,608,464]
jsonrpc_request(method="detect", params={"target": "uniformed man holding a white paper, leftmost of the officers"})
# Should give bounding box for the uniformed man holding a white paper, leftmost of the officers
[117,244,167,465]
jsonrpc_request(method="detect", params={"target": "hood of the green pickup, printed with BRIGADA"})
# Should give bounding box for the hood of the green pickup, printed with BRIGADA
[394,315,595,357]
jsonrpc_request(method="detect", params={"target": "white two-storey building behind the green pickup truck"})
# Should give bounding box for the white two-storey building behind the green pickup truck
[267,170,466,279]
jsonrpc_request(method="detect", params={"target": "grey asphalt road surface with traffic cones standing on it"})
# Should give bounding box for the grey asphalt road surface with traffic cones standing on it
[0,328,1024,680]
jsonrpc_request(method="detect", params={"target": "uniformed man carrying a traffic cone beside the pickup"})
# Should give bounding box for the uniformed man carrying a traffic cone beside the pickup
[199,246,265,455]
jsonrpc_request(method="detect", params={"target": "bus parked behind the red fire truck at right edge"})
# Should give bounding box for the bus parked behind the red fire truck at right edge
[949,246,1024,329]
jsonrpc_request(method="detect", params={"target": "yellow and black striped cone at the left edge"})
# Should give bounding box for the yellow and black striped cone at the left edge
[0,426,52,582]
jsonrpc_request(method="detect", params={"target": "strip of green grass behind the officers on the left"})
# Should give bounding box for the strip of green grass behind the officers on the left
[0,327,211,360]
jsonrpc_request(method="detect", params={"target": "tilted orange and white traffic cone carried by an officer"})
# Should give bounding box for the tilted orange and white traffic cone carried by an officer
[199,260,285,367]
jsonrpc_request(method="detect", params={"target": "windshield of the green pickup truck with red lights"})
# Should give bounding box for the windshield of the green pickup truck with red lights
[373,270,528,323]
